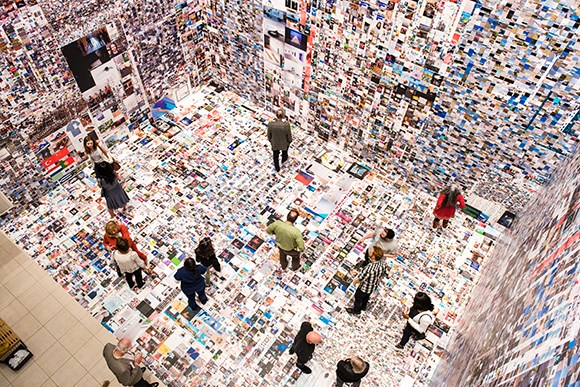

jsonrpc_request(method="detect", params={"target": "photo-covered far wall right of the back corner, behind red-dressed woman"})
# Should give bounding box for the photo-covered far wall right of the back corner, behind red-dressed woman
[203,0,580,210]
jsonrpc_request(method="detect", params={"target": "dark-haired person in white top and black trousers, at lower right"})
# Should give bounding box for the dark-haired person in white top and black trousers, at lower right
[395,292,435,350]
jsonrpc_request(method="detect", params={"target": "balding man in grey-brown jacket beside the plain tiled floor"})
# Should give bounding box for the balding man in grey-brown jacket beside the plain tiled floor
[103,339,159,387]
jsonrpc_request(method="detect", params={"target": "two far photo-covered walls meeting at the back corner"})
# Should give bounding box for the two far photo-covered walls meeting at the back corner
[0,0,580,212]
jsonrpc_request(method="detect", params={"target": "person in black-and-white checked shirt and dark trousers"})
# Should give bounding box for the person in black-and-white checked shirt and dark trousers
[346,246,388,314]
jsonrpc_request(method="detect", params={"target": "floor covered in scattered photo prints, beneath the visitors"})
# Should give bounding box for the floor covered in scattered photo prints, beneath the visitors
[2,87,493,386]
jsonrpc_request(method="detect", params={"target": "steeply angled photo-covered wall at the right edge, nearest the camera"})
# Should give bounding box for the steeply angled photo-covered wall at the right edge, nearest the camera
[433,152,580,387]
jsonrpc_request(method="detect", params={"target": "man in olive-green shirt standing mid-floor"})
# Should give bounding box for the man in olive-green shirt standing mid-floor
[266,210,304,271]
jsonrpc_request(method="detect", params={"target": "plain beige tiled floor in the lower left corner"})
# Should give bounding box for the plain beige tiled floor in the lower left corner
[0,232,163,387]
